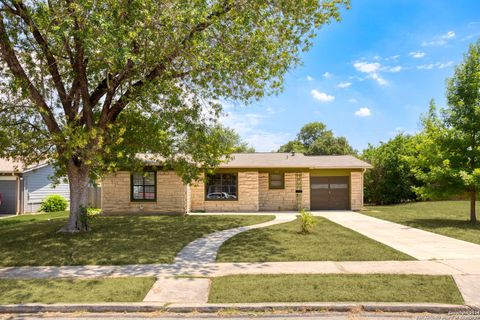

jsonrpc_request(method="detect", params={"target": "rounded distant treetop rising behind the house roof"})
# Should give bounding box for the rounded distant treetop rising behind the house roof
[278,122,356,155]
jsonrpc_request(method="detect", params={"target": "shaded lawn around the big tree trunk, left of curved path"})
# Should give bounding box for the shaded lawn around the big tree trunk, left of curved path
[0,213,273,266]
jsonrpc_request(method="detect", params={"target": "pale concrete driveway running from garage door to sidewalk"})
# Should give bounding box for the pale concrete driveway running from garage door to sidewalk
[313,211,480,260]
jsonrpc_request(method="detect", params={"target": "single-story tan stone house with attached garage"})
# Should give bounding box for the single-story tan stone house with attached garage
[102,153,371,214]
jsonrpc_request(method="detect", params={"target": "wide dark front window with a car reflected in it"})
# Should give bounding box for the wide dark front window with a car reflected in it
[205,173,238,200]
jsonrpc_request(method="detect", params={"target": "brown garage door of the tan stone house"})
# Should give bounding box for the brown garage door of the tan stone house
[310,177,350,210]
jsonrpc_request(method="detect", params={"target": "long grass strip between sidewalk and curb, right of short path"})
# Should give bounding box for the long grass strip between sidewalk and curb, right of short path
[208,274,463,304]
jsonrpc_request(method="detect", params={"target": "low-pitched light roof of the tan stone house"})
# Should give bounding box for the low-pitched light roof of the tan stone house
[219,152,372,169]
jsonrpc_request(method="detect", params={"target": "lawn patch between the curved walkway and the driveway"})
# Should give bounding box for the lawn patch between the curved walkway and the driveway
[217,218,415,262]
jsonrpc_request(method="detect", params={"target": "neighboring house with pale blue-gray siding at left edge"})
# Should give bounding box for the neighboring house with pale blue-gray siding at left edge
[0,159,70,214]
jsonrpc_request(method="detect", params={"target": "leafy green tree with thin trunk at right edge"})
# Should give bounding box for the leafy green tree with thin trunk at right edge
[410,88,480,223]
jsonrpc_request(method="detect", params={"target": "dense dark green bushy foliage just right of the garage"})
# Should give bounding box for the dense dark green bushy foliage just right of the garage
[361,134,420,204]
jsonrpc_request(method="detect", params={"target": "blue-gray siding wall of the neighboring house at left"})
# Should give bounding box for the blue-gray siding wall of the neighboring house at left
[23,166,70,212]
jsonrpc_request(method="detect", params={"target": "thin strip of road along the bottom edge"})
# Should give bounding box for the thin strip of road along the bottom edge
[0,312,480,320]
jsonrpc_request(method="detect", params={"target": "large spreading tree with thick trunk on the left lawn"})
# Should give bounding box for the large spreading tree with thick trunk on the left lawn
[0,0,348,232]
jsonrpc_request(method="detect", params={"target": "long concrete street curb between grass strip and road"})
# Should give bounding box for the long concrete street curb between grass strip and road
[0,303,478,314]
